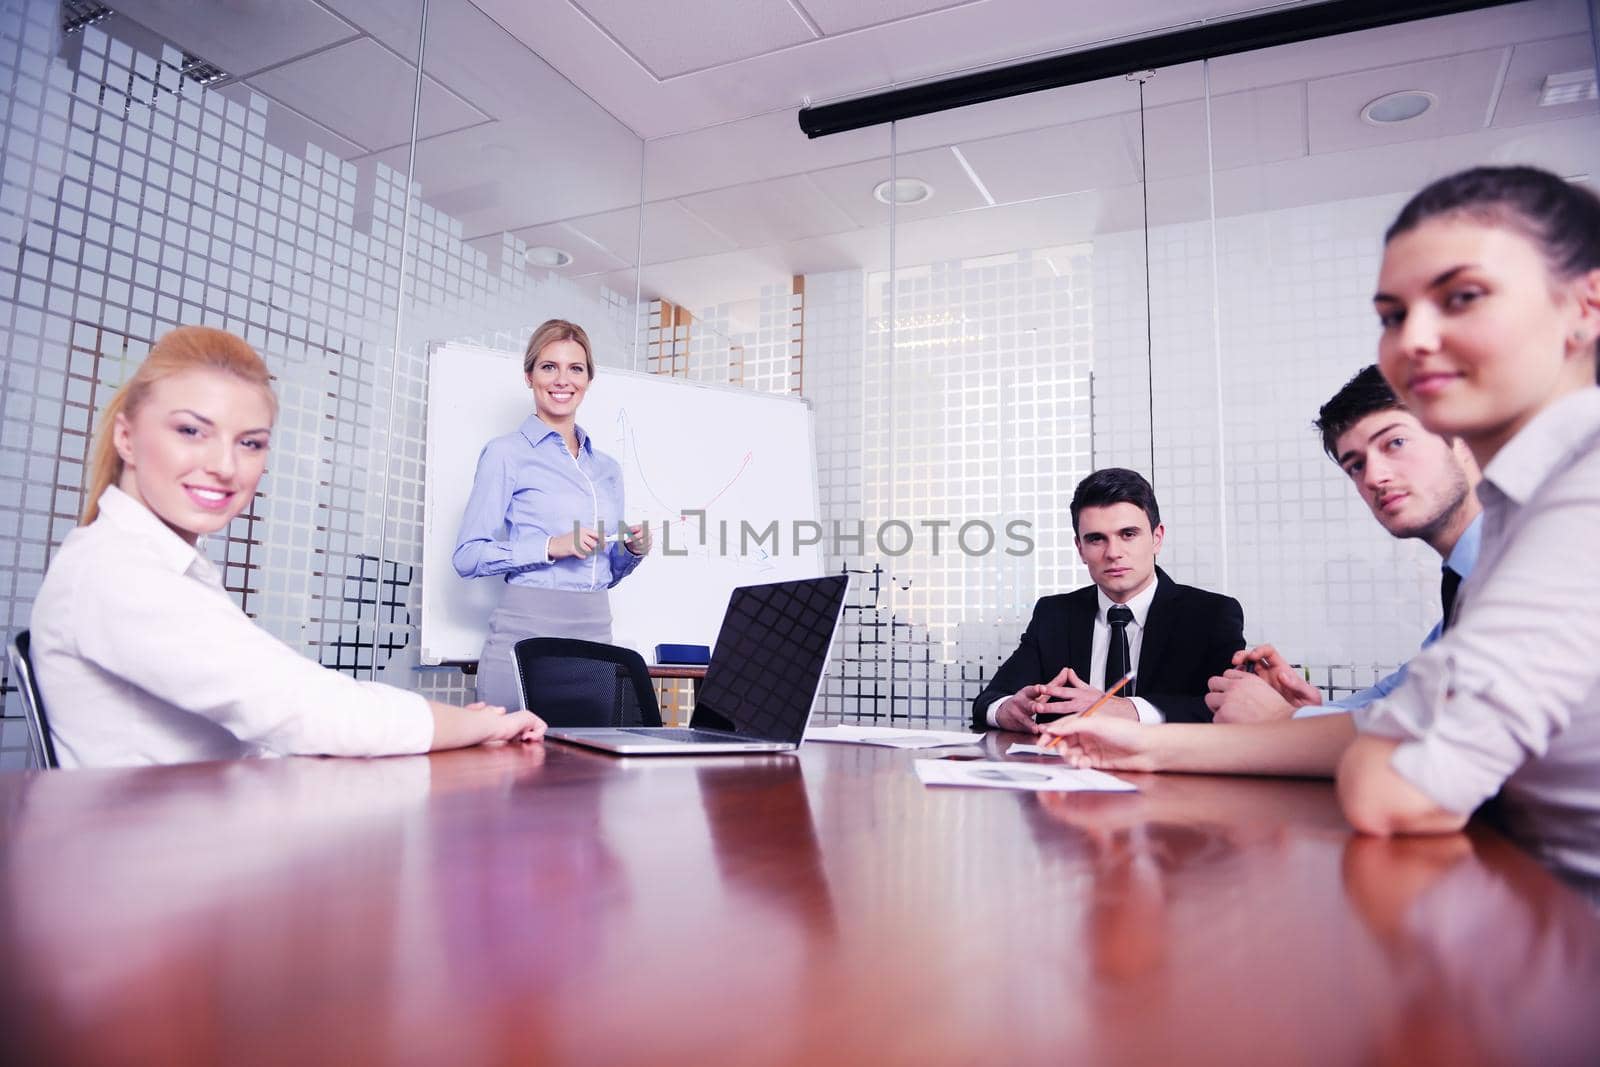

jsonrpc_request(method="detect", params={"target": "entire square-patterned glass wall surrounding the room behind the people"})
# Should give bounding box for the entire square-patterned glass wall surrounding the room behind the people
[0,0,1600,766]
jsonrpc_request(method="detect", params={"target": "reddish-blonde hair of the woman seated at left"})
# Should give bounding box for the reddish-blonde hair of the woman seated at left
[82,326,278,526]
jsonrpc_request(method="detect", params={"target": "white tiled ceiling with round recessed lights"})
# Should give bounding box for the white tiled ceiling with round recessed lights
[104,0,1600,307]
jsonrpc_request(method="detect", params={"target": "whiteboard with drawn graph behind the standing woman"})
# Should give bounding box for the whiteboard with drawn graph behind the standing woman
[419,344,822,665]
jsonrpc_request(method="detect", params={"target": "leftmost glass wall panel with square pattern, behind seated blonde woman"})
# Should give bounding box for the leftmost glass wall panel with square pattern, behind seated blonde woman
[0,0,438,766]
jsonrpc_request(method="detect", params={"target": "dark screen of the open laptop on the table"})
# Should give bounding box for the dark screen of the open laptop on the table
[690,574,850,742]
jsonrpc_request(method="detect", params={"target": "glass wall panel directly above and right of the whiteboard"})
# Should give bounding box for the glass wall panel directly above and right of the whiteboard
[640,112,904,718]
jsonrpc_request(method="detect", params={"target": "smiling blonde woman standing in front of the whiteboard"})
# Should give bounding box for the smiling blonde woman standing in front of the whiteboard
[453,318,650,707]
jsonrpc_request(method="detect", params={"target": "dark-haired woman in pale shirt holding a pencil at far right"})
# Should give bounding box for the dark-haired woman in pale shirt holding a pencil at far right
[1048,166,1600,901]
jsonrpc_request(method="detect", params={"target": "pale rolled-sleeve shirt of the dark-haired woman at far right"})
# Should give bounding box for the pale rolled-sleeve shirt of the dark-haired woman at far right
[1354,389,1600,880]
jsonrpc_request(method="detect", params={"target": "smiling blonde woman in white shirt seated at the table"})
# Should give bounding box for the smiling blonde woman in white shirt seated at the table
[32,326,544,768]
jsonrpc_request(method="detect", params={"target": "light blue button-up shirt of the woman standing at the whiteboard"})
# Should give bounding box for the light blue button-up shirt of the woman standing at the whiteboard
[451,414,642,592]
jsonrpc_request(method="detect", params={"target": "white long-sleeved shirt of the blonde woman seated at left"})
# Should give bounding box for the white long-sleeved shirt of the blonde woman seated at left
[32,486,434,766]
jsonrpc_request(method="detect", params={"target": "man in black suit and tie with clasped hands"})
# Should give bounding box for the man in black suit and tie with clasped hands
[973,467,1245,734]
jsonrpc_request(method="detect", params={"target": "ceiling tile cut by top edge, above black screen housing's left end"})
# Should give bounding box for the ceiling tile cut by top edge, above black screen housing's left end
[573,0,816,78]
